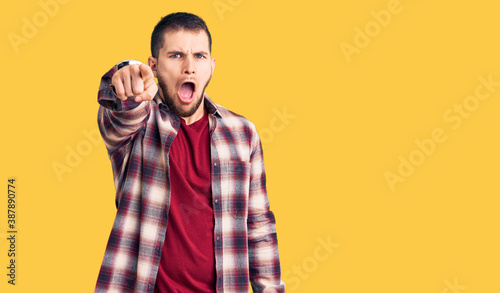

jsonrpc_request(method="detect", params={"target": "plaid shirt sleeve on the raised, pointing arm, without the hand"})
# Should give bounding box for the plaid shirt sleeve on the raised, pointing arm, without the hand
[97,67,151,154]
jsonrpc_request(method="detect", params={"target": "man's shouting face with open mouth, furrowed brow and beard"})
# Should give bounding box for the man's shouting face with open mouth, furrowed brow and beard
[148,30,215,117]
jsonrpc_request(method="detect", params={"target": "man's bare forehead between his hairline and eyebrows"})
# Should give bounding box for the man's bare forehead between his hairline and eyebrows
[161,29,210,52]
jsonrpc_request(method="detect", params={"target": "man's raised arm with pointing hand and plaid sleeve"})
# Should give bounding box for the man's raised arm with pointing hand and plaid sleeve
[97,64,158,153]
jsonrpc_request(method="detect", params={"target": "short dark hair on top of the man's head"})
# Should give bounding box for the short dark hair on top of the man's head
[151,12,212,58]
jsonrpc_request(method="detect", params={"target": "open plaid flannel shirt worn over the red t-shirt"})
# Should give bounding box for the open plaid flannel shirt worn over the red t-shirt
[95,68,285,293]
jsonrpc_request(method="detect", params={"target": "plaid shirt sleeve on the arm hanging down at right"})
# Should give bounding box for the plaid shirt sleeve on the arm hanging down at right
[247,124,285,293]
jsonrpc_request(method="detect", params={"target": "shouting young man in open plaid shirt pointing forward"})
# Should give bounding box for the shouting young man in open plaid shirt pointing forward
[95,13,285,293]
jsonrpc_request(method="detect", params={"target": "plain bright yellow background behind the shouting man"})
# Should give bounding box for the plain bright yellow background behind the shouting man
[0,0,500,293]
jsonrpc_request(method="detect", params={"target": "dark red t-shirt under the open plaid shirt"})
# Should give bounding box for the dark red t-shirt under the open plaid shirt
[154,112,216,293]
